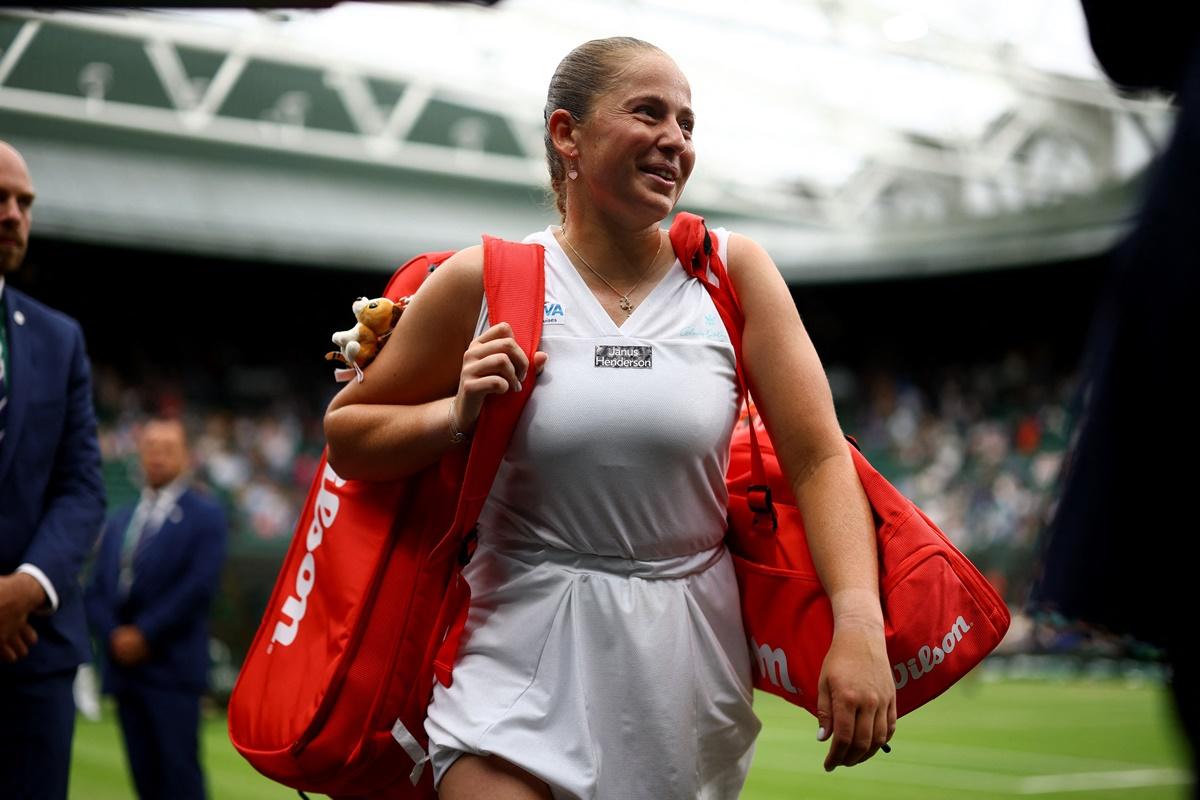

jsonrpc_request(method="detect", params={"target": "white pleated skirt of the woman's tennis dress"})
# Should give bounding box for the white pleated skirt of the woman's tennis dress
[426,541,761,800]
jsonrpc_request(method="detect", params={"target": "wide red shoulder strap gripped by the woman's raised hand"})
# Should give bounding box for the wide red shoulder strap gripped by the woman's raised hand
[448,236,546,539]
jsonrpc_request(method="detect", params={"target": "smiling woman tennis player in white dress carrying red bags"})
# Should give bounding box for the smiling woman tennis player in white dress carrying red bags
[325,38,895,800]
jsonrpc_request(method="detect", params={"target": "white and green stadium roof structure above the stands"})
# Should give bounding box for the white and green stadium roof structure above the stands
[0,0,1172,283]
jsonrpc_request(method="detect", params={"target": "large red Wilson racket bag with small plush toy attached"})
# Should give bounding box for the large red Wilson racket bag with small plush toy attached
[229,237,545,800]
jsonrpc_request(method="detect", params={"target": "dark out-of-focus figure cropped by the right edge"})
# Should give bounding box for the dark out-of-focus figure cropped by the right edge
[1033,0,1200,796]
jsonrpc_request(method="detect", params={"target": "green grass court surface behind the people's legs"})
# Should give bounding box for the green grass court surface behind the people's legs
[71,676,1188,800]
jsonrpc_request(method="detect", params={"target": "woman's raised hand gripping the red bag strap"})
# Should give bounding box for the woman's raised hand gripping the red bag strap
[454,323,547,433]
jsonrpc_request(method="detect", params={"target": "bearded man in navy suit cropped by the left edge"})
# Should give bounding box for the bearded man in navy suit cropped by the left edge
[0,142,104,800]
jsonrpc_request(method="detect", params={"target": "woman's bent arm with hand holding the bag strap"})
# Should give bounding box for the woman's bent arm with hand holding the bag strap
[325,247,544,481]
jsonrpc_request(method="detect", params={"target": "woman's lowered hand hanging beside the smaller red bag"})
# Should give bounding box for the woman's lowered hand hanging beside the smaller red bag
[817,620,896,772]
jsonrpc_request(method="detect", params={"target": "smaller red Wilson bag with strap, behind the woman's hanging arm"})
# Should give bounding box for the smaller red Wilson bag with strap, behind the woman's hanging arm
[671,213,1010,716]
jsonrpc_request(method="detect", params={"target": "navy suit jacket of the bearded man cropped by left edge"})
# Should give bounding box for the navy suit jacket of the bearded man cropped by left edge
[0,285,104,681]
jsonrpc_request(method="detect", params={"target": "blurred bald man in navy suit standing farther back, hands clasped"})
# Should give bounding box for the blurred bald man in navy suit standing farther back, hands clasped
[86,420,226,800]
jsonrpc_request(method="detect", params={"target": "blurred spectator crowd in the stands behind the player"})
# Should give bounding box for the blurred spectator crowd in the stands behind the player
[88,351,1074,603]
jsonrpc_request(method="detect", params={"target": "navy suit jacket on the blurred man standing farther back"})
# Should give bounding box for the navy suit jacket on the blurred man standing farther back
[86,489,227,693]
